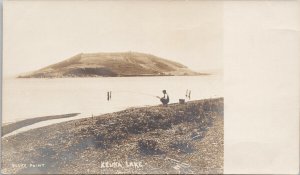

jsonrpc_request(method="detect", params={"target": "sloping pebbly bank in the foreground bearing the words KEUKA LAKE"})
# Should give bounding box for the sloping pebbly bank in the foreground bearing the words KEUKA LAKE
[2,98,224,174]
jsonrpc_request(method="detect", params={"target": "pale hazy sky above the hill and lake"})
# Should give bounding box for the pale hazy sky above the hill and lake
[3,1,223,75]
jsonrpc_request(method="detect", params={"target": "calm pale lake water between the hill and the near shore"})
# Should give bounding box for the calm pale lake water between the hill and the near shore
[2,75,223,123]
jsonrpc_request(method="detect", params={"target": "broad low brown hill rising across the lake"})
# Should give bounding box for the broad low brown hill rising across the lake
[18,52,199,78]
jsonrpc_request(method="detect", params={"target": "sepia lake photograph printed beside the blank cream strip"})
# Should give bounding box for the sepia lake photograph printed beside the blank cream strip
[1,0,224,174]
